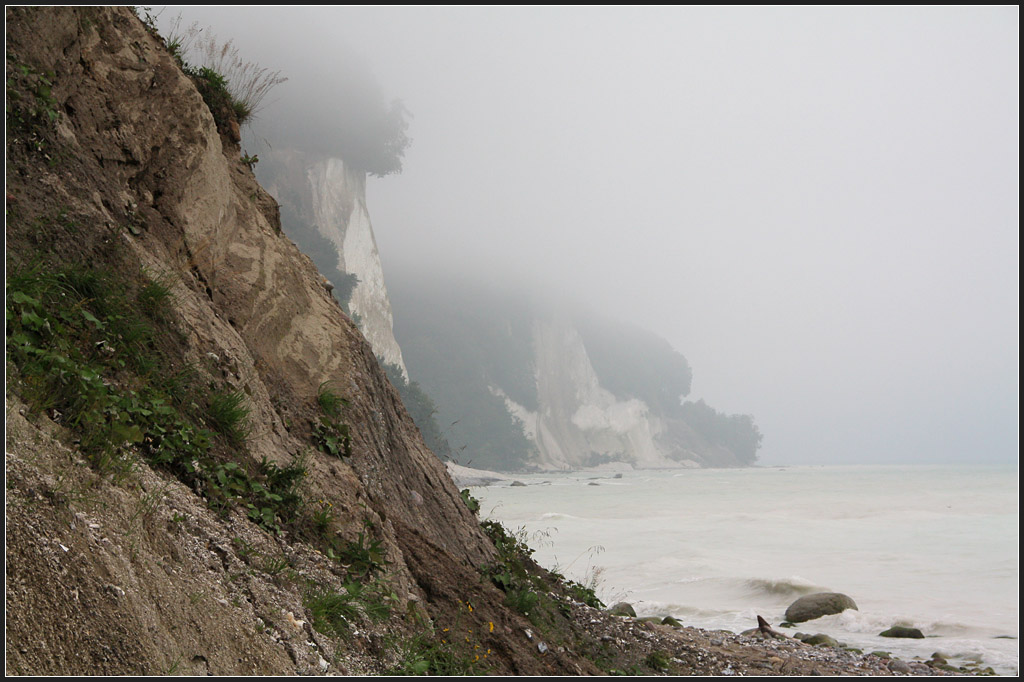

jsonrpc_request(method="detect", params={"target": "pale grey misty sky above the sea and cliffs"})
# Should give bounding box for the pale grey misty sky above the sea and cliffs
[160,6,1020,464]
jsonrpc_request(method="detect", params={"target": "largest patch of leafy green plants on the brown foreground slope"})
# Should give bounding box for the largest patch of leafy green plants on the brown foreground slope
[5,265,313,540]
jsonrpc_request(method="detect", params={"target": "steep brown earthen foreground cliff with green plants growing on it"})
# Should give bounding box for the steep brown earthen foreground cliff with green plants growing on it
[5,7,593,675]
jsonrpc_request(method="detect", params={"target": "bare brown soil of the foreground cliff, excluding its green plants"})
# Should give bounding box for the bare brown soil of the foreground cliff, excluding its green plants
[6,8,540,674]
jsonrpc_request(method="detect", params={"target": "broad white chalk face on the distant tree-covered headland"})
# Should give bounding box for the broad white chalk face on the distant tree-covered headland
[493,319,680,469]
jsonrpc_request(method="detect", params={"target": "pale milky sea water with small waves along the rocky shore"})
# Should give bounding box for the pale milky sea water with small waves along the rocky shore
[472,466,1019,675]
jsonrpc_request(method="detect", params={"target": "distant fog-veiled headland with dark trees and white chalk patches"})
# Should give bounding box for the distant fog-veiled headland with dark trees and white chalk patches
[391,272,760,470]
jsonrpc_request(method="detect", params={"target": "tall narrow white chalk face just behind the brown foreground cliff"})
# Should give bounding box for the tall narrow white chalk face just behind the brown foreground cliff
[261,151,409,379]
